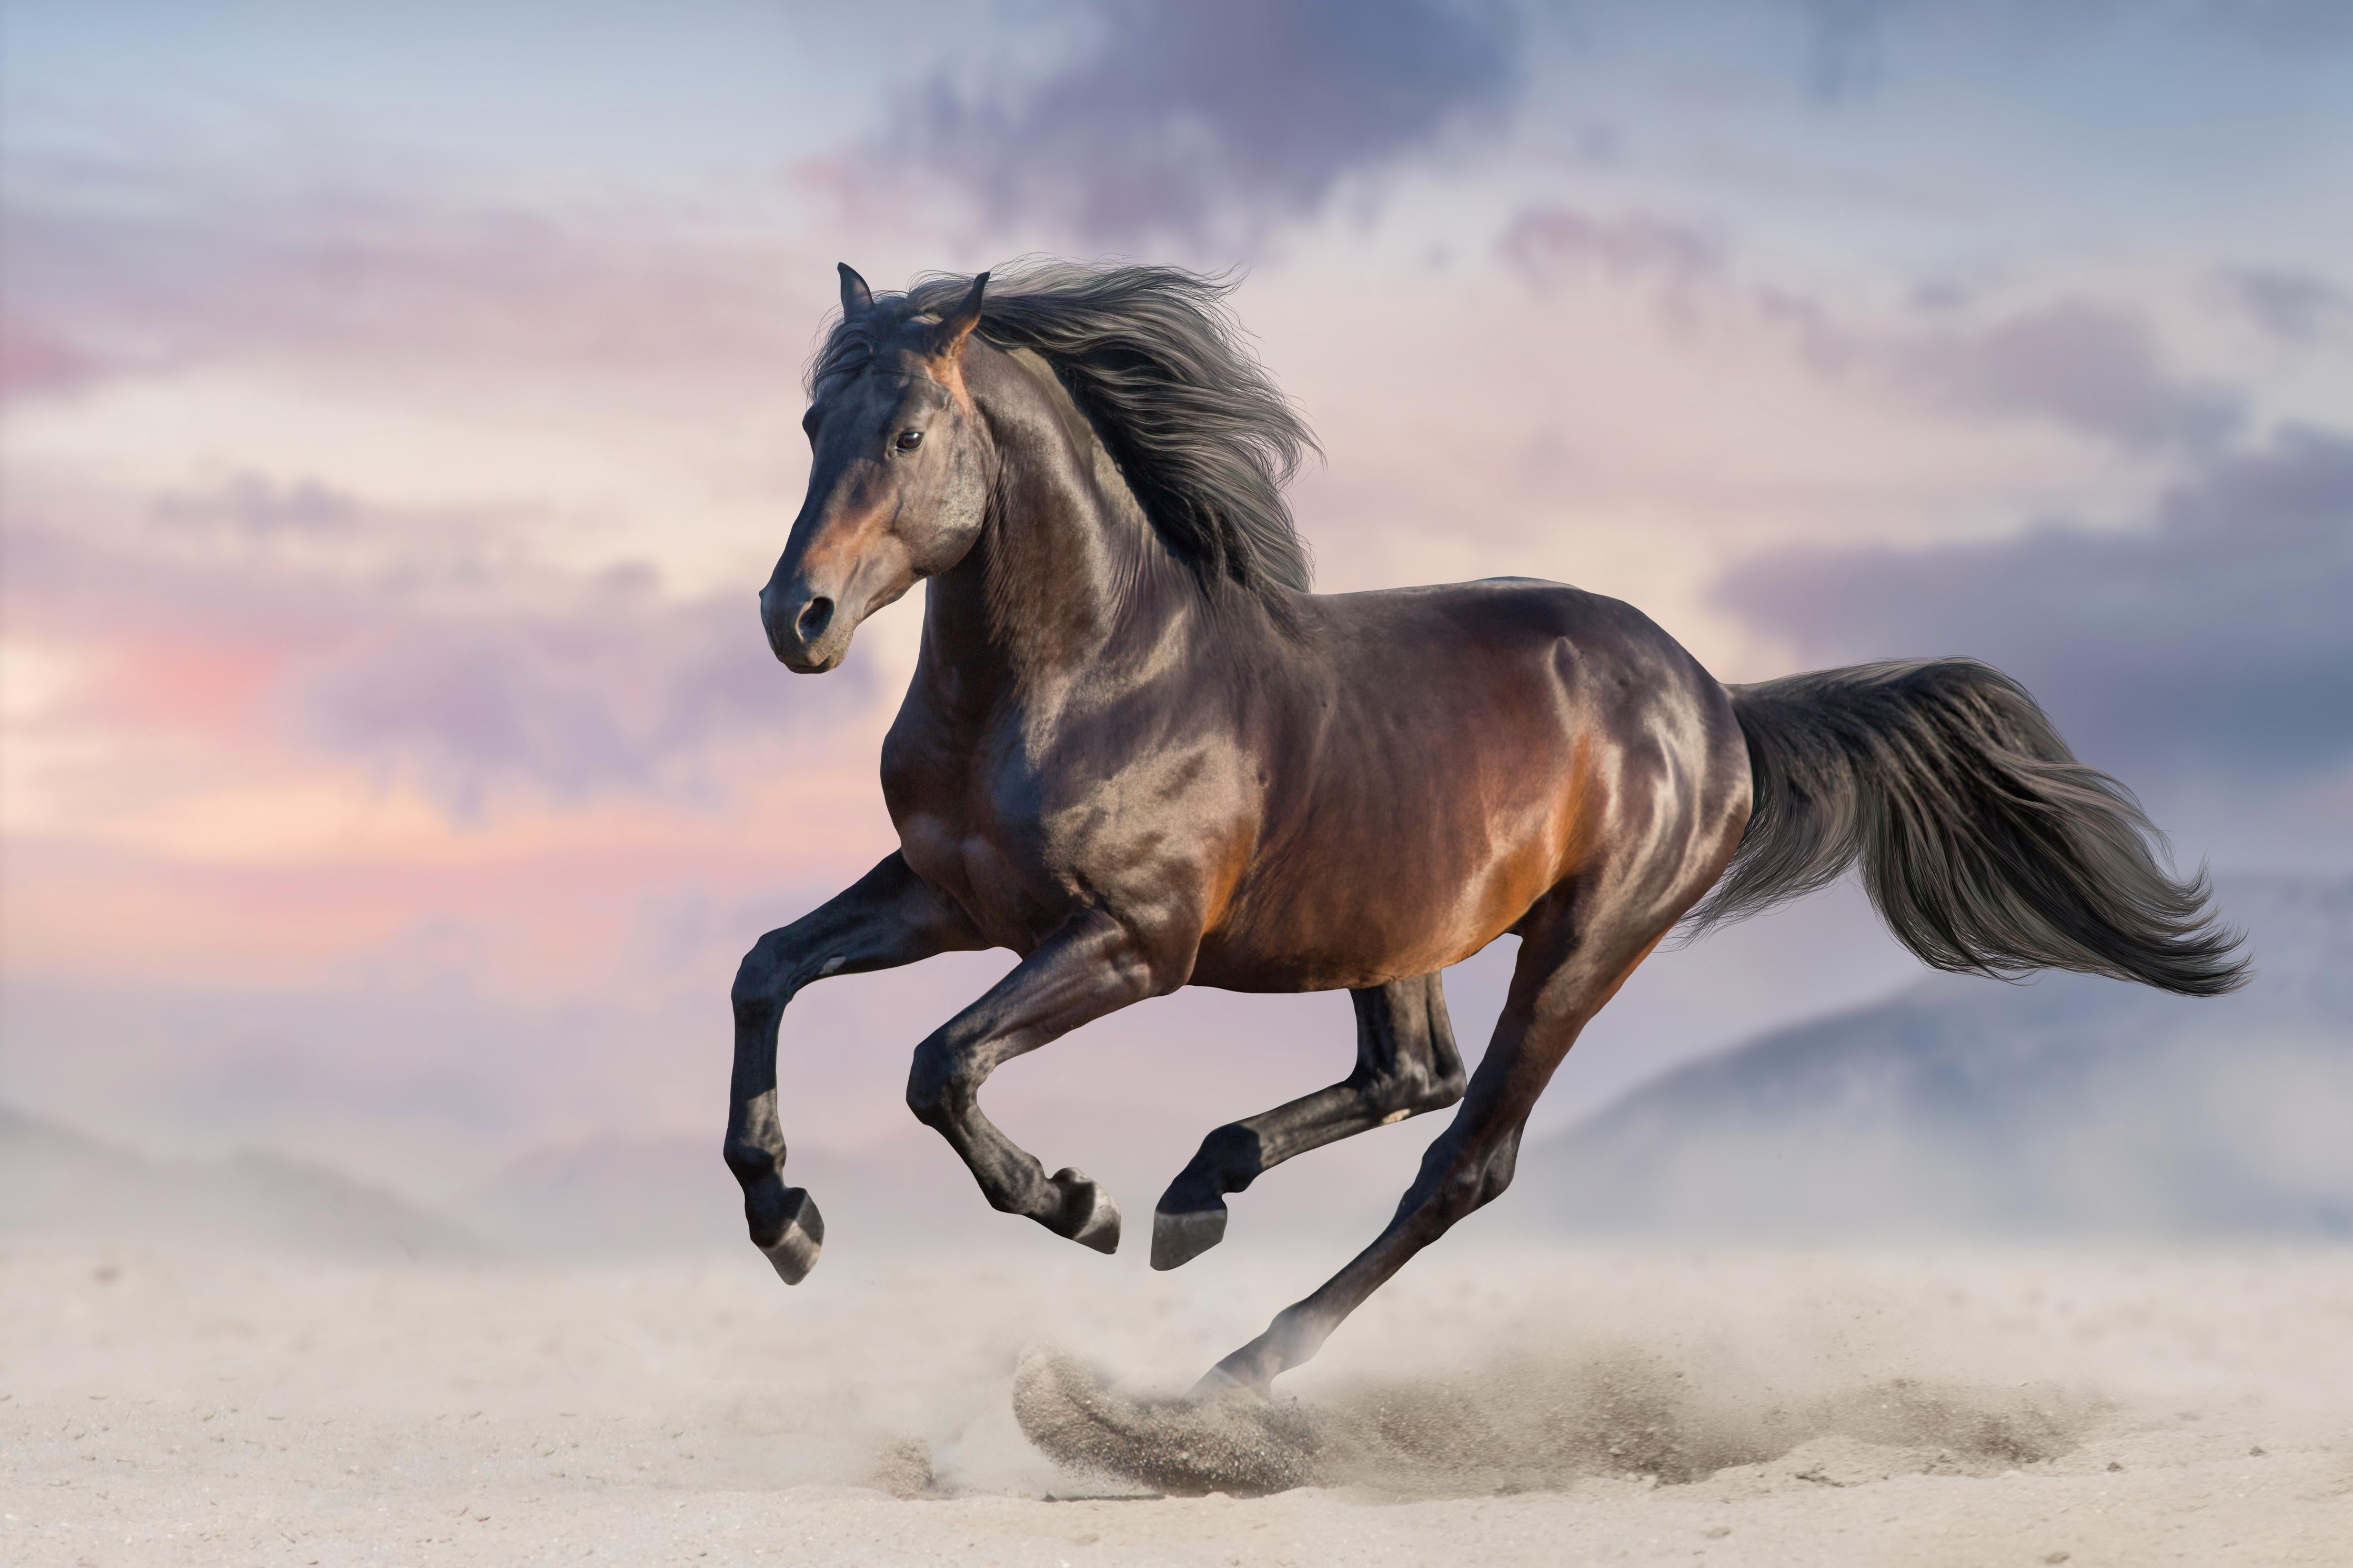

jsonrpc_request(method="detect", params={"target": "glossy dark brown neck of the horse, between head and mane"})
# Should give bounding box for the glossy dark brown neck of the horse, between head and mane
[924,343,1193,693]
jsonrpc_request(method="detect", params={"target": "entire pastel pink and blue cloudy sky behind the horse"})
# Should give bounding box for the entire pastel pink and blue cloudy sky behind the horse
[0,0,2353,1216]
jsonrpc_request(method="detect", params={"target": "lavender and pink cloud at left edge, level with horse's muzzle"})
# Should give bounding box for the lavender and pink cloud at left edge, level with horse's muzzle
[5,475,873,816]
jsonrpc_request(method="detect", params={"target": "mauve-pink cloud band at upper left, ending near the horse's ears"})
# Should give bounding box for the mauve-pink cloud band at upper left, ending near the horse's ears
[0,146,817,397]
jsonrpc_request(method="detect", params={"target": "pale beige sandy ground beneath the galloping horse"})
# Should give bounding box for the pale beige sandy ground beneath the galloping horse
[0,1243,2353,1568]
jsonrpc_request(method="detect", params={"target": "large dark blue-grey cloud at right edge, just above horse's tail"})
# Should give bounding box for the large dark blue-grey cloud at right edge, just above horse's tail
[1720,430,2353,781]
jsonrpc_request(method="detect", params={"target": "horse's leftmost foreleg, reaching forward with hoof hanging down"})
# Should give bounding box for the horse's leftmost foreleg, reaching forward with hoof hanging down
[727,853,988,1286]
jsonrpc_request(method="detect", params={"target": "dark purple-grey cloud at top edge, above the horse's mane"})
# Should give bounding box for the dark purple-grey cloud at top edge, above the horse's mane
[901,0,1520,242]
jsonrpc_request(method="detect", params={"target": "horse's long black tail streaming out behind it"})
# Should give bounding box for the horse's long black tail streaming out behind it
[1692,658,2247,997]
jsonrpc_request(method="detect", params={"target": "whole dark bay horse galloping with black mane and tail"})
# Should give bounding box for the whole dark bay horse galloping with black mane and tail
[725,261,2245,1394]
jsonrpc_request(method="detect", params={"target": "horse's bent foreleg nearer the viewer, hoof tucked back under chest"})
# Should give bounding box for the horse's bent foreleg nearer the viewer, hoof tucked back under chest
[906,910,1165,1253]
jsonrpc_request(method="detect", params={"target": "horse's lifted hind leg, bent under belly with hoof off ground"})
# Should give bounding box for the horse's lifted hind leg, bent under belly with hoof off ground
[1153,973,1464,1269]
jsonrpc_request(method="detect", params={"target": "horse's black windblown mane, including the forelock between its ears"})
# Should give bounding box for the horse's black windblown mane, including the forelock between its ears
[809,261,1318,597]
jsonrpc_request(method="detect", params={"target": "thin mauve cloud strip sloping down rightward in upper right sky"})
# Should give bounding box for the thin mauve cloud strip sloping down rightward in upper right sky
[1496,205,2247,451]
